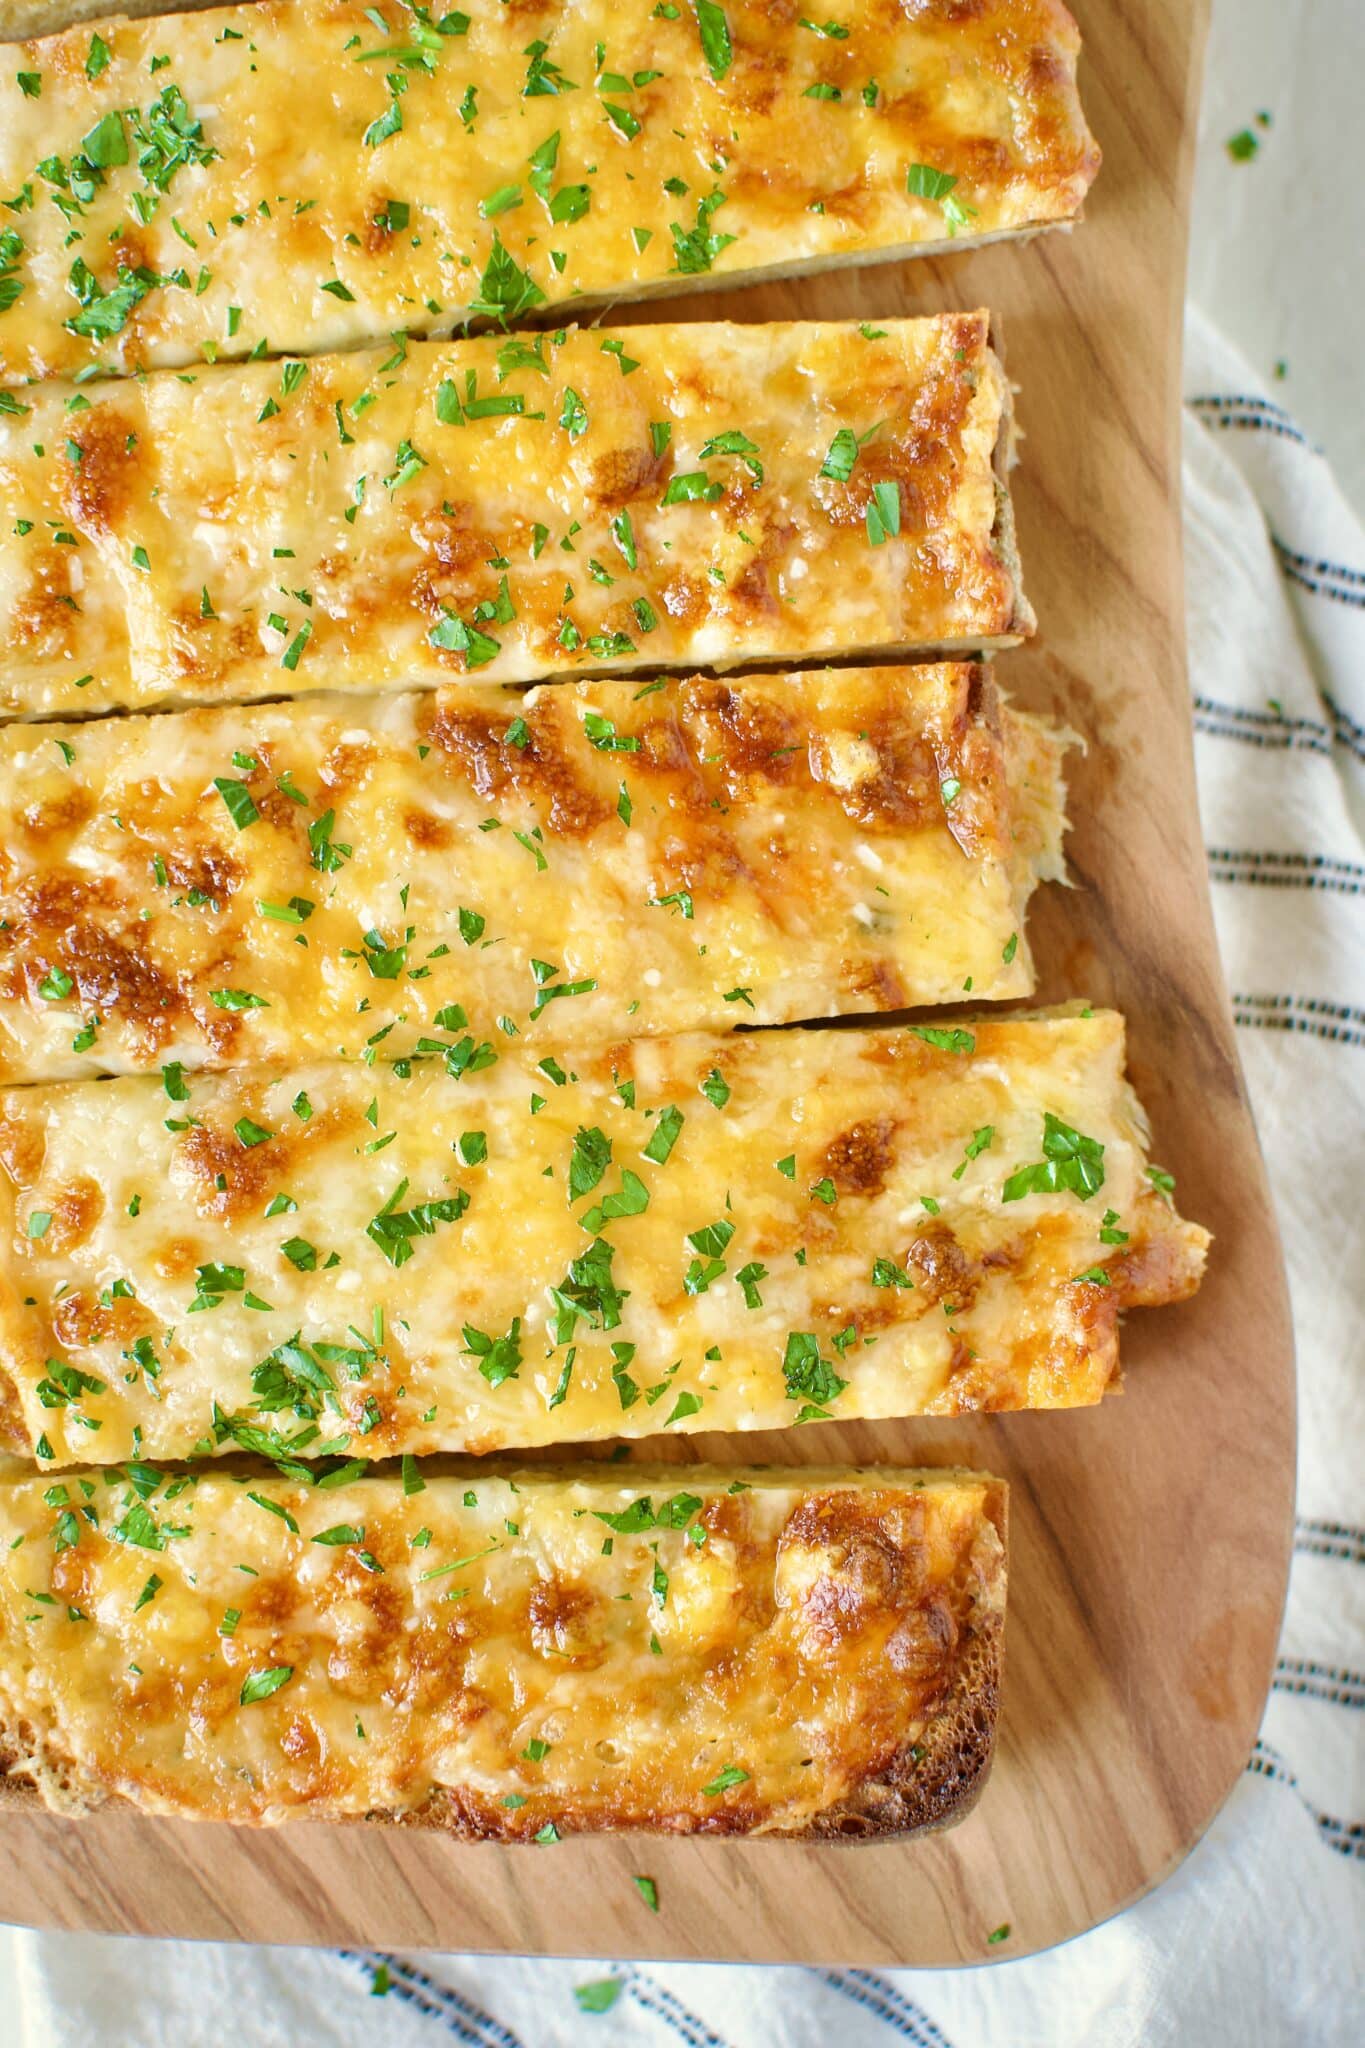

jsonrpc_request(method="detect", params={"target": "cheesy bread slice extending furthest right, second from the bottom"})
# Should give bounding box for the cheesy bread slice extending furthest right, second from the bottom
[0,1003,1205,1464]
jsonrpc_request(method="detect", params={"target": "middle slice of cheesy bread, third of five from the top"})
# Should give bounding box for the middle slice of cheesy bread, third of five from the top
[0,666,1062,1081]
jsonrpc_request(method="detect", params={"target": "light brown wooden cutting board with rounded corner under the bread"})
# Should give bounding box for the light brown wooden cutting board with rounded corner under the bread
[0,0,1293,1964]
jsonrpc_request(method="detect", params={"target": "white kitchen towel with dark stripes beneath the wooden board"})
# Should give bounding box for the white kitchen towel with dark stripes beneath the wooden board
[0,315,1365,2048]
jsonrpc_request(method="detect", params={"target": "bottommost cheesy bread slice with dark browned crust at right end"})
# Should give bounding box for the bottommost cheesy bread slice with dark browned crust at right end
[0,1464,1005,1843]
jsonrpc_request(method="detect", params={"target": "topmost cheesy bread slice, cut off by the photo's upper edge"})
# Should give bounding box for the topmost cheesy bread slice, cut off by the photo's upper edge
[0,0,1099,383]
